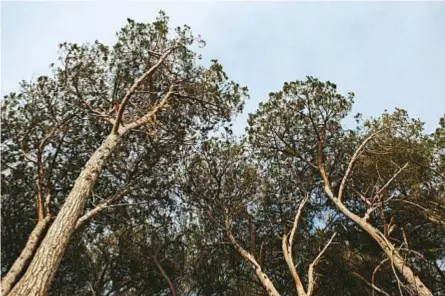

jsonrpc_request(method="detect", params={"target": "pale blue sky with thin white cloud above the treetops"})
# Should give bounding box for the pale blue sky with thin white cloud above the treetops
[1,1,445,134]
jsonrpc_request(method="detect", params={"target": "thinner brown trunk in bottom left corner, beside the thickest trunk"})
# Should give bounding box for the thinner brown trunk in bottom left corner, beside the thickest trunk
[1,215,51,296]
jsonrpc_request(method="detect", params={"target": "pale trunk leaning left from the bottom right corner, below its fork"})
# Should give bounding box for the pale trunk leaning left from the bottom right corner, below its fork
[332,192,433,296]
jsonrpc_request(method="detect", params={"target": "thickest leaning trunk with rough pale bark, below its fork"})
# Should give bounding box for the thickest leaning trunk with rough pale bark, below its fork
[9,134,121,296]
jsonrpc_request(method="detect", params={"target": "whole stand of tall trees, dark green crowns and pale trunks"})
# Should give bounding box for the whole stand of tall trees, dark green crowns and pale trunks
[1,12,445,296]
